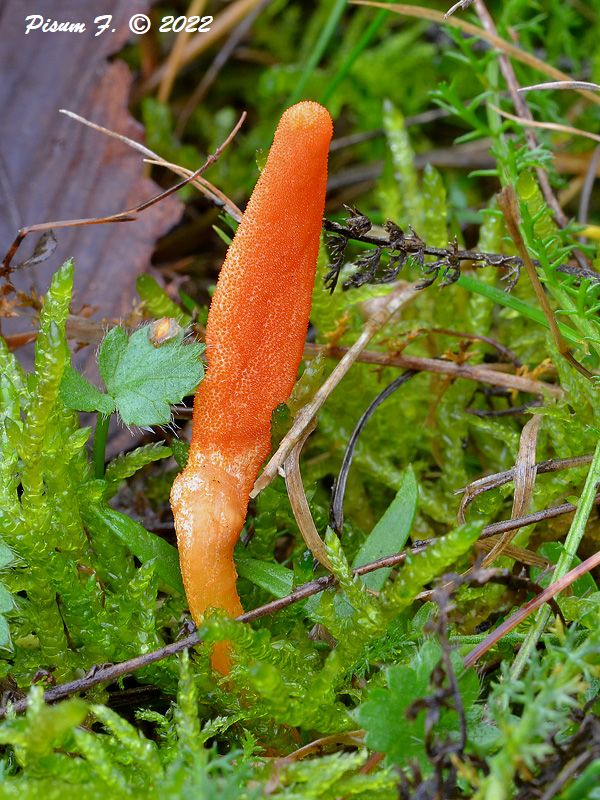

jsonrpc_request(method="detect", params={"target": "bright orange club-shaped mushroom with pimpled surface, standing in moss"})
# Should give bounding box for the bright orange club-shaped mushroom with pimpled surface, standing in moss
[171,102,332,673]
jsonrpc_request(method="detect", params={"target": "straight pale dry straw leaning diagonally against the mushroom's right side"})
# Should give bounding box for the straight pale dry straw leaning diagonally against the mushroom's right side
[250,284,418,497]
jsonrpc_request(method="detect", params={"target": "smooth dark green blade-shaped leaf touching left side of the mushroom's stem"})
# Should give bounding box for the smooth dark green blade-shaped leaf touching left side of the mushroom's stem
[84,505,183,594]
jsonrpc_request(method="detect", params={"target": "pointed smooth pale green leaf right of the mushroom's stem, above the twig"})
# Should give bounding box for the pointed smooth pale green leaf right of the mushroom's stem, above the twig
[352,467,418,591]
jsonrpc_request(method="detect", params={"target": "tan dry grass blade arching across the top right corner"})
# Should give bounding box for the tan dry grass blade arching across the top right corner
[351,0,600,104]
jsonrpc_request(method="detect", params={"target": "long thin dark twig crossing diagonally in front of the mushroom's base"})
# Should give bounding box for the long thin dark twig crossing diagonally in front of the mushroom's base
[0,494,600,719]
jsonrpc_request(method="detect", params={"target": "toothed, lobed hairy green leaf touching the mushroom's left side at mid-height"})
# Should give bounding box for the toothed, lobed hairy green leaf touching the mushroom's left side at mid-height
[98,326,204,426]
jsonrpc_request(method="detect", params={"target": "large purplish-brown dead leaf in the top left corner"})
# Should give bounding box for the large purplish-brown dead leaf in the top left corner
[0,0,182,344]
